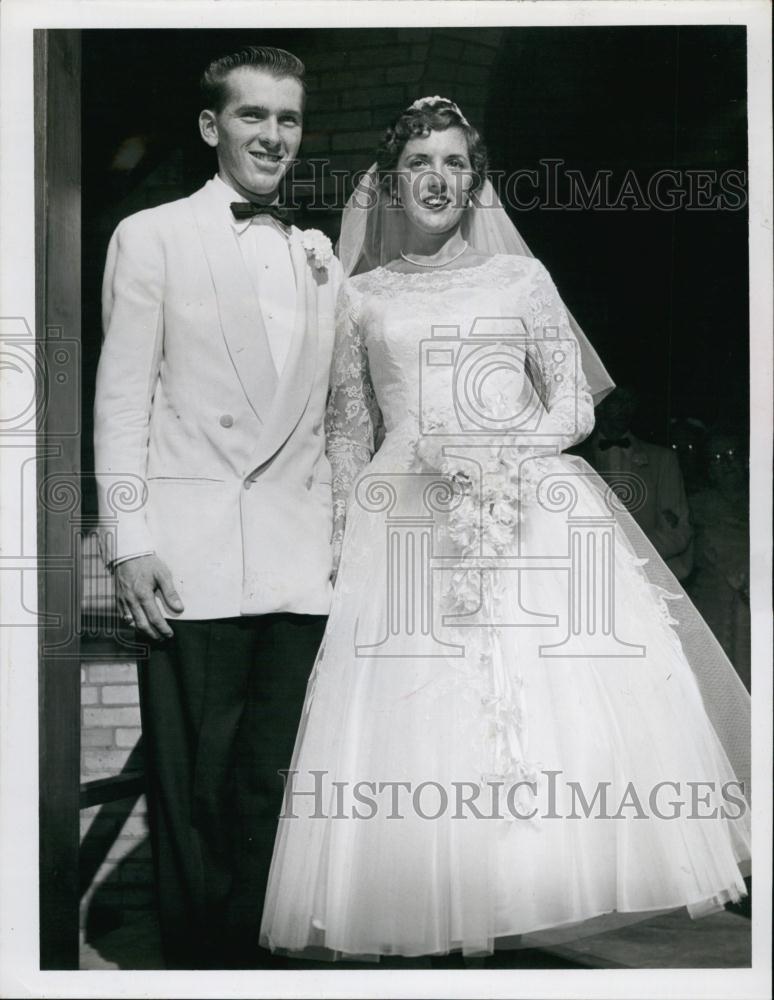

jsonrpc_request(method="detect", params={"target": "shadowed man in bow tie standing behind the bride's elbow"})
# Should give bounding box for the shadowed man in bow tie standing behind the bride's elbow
[581,386,693,580]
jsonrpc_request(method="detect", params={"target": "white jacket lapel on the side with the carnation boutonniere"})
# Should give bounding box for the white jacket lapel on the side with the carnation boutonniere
[250,228,318,469]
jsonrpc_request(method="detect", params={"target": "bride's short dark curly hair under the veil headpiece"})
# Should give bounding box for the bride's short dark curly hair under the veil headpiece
[376,97,489,193]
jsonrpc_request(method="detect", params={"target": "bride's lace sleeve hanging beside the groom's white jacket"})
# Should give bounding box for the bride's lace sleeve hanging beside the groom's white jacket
[325,281,379,573]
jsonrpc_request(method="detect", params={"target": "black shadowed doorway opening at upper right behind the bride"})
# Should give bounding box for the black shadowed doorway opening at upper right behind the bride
[487,26,749,434]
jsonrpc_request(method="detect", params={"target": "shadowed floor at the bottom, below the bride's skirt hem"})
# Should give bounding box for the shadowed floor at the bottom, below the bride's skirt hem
[81,910,750,969]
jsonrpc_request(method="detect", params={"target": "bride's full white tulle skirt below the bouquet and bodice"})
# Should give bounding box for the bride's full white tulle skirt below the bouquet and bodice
[261,445,750,958]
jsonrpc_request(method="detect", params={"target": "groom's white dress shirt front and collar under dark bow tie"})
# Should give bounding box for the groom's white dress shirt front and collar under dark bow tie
[215,175,296,376]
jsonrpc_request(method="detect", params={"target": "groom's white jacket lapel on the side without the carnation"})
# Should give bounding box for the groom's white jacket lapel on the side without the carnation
[191,181,278,423]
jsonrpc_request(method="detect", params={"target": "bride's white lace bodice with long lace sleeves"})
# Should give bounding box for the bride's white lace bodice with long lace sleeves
[326,254,594,560]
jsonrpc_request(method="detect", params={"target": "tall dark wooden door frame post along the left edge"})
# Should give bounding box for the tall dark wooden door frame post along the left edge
[33,30,81,969]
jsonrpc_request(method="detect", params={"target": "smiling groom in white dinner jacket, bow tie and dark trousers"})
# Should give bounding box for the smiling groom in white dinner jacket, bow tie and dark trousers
[95,47,341,968]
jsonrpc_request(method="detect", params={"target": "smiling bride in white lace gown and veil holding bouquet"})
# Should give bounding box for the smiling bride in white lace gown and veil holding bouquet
[261,97,750,959]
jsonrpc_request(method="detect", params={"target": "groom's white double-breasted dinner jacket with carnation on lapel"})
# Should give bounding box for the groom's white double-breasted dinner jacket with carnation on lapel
[95,181,341,619]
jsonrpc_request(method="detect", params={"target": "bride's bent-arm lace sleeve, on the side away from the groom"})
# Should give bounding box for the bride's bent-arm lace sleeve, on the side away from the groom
[527,261,594,451]
